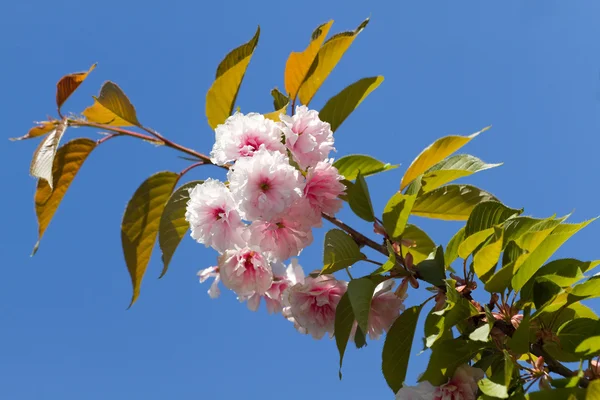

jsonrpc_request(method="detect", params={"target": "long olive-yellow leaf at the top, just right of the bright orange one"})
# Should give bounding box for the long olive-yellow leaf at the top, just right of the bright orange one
[298,18,369,105]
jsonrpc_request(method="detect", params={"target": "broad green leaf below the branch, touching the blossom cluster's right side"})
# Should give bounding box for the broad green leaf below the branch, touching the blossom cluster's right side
[321,229,365,274]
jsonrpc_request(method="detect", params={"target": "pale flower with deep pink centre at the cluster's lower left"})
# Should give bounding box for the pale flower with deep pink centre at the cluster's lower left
[219,247,273,299]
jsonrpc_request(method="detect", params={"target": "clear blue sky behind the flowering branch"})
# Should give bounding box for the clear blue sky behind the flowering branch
[0,0,600,400]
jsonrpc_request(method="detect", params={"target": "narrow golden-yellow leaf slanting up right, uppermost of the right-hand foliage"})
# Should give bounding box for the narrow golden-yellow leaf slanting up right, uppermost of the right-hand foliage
[400,126,490,190]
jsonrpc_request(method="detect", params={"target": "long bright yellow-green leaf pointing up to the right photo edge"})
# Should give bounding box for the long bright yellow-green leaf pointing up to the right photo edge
[512,218,596,290]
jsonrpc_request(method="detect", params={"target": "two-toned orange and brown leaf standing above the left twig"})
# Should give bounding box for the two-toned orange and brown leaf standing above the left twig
[83,81,140,126]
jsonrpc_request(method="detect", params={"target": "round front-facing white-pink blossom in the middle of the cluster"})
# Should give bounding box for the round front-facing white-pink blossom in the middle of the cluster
[227,148,304,221]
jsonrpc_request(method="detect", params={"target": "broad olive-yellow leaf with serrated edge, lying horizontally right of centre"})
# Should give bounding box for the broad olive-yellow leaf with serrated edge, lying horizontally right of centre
[412,185,496,221]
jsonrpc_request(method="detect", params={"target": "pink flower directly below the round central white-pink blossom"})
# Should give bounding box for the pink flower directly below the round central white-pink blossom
[248,198,321,261]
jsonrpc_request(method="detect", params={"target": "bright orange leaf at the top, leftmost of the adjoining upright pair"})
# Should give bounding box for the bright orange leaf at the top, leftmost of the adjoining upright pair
[284,20,333,99]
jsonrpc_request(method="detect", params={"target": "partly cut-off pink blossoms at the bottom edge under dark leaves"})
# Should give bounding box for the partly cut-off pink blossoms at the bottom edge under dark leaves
[396,364,484,400]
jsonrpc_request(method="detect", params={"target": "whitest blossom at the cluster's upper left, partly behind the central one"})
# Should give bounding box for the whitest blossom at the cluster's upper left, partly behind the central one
[210,112,285,165]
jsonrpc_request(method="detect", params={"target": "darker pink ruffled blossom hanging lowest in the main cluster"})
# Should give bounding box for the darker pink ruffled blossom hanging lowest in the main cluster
[283,275,347,339]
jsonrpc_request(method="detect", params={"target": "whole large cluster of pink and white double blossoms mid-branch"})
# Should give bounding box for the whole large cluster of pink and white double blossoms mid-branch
[185,106,404,339]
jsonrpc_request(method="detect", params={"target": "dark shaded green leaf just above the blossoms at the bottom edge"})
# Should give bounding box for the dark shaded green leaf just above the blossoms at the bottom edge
[419,338,488,386]
